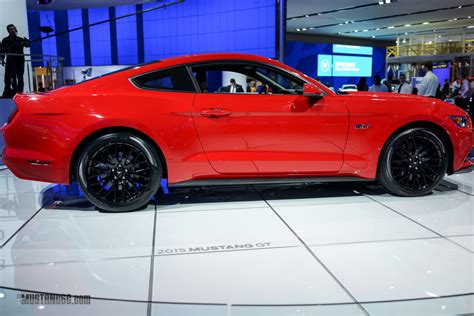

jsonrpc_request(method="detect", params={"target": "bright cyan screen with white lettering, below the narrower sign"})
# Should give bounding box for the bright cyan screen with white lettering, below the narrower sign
[332,55,372,77]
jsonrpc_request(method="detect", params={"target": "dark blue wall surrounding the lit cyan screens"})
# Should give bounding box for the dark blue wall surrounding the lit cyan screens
[284,41,385,89]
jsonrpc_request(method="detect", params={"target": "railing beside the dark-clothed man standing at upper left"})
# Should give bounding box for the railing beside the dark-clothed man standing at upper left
[0,53,65,94]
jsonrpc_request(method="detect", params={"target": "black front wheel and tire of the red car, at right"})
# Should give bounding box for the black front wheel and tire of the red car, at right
[378,128,449,197]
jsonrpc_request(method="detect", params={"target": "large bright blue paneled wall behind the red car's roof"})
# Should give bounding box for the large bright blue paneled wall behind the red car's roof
[28,0,277,66]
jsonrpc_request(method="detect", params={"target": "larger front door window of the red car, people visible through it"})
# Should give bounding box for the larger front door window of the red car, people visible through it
[192,62,304,94]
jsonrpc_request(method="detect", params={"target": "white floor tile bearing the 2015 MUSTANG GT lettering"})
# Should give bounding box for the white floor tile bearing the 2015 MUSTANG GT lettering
[155,207,301,255]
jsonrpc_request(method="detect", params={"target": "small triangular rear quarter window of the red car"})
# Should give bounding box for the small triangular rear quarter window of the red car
[133,67,196,92]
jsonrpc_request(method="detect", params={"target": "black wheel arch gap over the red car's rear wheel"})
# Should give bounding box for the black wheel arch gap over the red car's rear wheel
[69,126,168,182]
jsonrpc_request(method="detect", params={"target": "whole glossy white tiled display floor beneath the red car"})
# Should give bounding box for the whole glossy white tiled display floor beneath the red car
[0,170,474,315]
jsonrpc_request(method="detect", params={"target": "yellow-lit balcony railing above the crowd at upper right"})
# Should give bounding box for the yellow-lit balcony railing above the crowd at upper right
[386,40,474,58]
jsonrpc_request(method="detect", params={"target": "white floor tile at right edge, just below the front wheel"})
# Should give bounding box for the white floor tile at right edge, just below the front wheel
[375,192,474,236]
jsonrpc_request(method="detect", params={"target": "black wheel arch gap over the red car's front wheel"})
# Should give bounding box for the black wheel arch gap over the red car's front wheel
[377,121,454,178]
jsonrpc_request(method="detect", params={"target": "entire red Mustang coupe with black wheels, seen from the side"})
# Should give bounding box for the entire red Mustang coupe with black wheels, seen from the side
[3,54,472,211]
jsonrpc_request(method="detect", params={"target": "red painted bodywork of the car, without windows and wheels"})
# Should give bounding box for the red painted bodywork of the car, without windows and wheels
[3,54,472,184]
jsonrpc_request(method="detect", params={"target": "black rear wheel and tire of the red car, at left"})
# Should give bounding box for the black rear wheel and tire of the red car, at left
[77,133,162,212]
